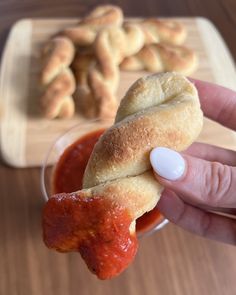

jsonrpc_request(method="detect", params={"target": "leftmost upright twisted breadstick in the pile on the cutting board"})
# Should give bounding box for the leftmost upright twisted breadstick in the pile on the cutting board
[40,37,75,119]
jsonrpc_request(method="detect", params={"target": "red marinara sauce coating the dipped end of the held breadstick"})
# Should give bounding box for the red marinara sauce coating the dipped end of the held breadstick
[43,193,138,279]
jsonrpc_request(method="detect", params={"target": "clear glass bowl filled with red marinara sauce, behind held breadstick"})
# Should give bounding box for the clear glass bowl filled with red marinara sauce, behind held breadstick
[41,120,168,237]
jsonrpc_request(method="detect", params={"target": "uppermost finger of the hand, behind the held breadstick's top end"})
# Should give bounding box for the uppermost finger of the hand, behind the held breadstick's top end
[190,78,236,130]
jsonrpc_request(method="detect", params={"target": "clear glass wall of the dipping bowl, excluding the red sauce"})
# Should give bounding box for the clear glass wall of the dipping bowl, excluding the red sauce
[41,120,168,236]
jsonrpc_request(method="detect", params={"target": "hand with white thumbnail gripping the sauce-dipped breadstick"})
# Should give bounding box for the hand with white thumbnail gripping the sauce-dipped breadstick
[150,80,236,245]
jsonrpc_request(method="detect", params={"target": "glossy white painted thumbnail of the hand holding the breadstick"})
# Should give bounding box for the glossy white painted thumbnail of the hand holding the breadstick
[150,147,185,180]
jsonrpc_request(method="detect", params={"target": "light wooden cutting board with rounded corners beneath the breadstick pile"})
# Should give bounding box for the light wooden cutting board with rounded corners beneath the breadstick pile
[0,18,236,167]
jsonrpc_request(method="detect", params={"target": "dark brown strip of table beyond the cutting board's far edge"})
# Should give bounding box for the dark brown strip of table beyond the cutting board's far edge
[0,0,236,57]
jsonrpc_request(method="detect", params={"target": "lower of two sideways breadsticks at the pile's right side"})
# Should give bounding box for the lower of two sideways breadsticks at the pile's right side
[120,43,197,75]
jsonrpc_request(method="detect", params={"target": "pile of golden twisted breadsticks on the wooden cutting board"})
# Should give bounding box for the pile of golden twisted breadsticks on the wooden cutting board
[40,5,197,119]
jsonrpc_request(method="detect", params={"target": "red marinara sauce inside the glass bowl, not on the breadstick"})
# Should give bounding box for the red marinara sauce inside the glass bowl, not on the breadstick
[53,129,164,233]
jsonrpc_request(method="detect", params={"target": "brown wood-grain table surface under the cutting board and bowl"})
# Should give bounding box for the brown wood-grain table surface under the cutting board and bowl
[0,0,236,295]
